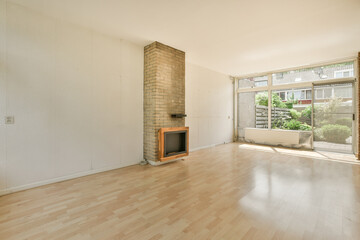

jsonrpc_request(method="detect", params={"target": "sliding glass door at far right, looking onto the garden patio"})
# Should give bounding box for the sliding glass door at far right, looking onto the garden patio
[313,82,354,153]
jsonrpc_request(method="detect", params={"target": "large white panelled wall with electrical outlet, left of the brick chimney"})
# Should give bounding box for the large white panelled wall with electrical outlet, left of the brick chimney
[0,0,143,194]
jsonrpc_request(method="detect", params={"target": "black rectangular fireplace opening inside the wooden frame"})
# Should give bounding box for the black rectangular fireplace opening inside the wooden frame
[164,131,187,157]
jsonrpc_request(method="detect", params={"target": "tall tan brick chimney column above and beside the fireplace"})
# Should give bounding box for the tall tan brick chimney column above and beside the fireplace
[144,42,185,161]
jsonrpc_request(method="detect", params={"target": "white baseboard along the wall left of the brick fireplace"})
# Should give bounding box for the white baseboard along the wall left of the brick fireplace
[0,163,136,196]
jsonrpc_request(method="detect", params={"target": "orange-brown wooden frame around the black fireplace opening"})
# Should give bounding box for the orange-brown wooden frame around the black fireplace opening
[159,127,189,162]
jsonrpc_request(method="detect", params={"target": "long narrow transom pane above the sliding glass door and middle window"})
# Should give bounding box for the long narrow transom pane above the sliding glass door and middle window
[272,62,354,85]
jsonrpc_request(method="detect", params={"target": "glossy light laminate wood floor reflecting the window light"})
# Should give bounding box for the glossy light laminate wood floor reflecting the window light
[0,143,360,240]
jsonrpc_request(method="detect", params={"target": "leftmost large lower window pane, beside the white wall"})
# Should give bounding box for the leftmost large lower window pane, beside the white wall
[238,92,268,140]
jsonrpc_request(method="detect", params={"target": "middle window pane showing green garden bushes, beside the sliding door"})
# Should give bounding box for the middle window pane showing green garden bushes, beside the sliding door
[271,88,311,131]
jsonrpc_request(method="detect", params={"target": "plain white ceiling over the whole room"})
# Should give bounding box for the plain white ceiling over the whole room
[9,0,360,75]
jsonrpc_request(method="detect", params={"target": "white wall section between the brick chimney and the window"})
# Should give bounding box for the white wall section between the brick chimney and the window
[185,63,233,150]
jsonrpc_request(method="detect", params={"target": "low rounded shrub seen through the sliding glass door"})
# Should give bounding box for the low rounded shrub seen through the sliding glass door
[321,124,351,143]
